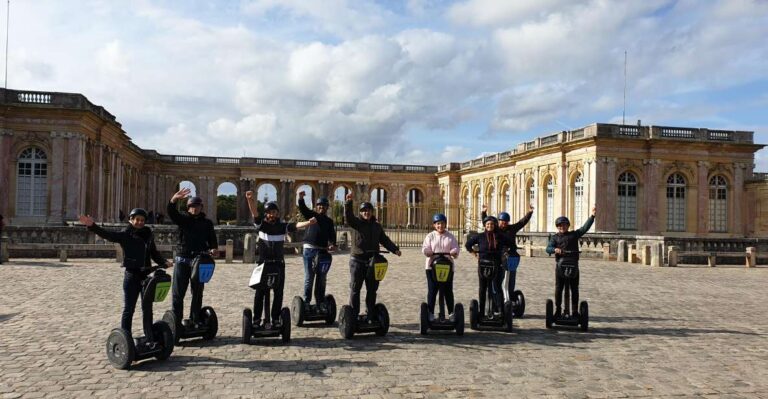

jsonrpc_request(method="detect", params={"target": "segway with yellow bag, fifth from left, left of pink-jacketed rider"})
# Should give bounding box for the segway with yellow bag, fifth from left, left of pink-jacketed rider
[339,251,389,339]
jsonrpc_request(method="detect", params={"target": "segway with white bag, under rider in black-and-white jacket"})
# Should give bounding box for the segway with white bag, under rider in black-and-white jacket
[242,260,291,344]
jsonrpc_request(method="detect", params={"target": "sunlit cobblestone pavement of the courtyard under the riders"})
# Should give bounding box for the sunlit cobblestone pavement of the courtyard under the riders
[0,249,768,398]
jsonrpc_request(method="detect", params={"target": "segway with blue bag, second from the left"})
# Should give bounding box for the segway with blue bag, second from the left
[163,252,219,344]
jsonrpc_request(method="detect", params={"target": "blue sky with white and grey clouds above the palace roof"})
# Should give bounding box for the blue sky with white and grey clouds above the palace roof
[2,0,768,172]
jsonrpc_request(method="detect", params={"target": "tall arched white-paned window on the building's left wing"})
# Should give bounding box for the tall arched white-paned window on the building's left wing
[16,147,48,216]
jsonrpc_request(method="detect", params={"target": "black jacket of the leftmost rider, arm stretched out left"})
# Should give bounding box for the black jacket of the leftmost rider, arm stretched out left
[88,224,166,272]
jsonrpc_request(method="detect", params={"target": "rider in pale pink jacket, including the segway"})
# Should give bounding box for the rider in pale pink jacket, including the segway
[420,213,464,335]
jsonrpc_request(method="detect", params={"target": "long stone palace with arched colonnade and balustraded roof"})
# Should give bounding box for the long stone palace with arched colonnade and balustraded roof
[0,90,768,238]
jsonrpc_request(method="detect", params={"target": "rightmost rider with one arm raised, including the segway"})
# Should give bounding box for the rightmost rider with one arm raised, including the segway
[546,208,597,331]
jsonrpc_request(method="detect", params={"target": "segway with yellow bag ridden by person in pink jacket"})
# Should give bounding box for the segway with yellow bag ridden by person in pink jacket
[420,252,464,336]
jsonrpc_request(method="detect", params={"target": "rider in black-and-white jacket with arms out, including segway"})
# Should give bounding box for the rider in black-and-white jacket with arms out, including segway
[242,191,317,344]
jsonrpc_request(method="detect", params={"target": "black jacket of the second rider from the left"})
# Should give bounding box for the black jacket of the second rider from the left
[167,202,219,258]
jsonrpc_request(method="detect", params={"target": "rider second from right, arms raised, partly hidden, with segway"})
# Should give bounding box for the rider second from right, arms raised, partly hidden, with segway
[481,205,533,317]
